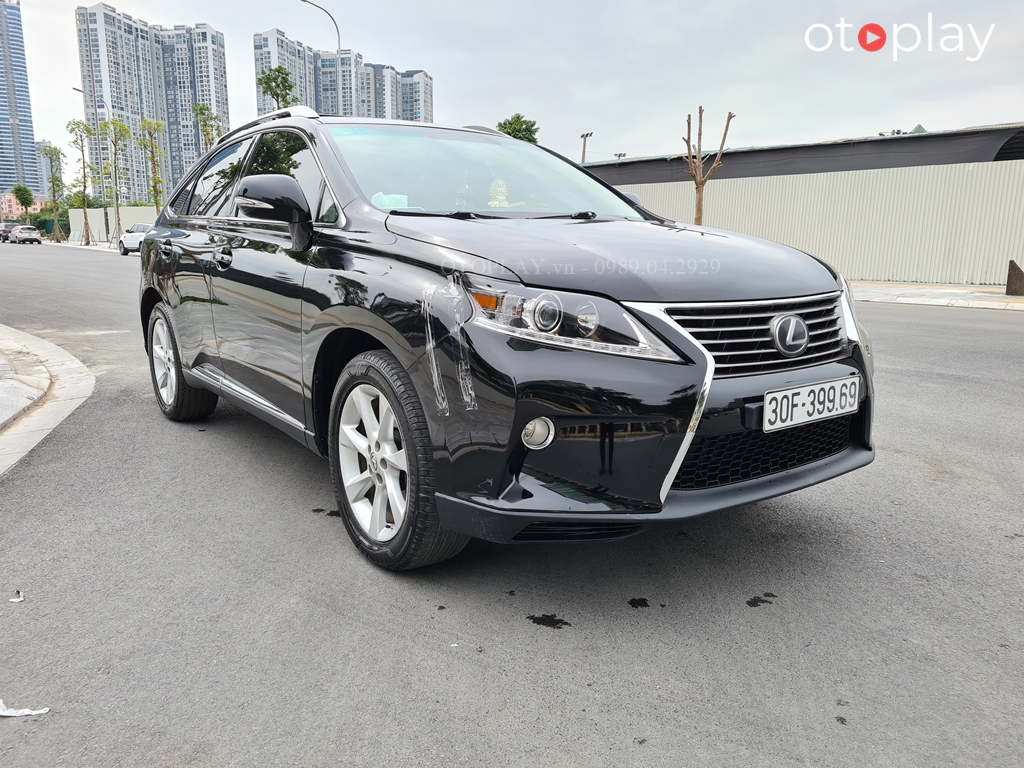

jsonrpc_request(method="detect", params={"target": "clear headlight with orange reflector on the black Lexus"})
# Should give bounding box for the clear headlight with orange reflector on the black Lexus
[466,278,682,362]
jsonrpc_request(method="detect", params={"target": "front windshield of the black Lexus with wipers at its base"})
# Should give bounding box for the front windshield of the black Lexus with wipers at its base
[326,125,640,218]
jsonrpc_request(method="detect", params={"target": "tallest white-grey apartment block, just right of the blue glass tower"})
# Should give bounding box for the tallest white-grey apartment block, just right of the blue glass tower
[75,3,229,202]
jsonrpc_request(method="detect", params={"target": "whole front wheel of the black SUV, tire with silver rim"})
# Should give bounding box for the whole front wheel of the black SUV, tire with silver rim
[329,350,469,570]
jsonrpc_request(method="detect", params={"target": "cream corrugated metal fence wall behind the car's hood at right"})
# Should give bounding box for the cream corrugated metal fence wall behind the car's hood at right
[618,160,1024,285]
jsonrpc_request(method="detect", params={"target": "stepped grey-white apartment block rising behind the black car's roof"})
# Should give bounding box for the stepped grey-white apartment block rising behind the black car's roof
[253,30,434,123]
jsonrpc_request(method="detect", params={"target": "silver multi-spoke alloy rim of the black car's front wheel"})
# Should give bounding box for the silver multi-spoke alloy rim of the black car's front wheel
[338,384,409,542]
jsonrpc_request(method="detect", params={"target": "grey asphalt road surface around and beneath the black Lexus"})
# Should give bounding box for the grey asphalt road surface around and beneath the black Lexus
[0,246,1024,768]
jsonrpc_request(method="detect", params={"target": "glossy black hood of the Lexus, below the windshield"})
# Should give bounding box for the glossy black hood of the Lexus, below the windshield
[387,215,836,302]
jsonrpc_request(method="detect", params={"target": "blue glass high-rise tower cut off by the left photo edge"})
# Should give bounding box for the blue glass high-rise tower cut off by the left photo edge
[0,0,44,193]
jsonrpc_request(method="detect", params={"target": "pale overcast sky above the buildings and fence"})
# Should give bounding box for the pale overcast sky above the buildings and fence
[22,0,1024,161]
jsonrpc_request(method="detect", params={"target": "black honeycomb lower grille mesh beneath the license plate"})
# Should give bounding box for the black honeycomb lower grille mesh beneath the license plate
[672,414,854,490]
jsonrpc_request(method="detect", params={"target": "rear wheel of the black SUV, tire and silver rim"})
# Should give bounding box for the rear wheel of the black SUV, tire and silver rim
[147,302,217,421]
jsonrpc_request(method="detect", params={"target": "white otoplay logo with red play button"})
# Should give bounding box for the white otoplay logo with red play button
[804,13,995,61]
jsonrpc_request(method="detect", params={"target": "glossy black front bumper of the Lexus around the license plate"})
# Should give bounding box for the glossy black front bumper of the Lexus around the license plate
[421,290,874,543]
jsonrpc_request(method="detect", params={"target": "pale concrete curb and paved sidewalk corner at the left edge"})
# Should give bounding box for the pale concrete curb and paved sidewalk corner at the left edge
[0,325,96,475]
